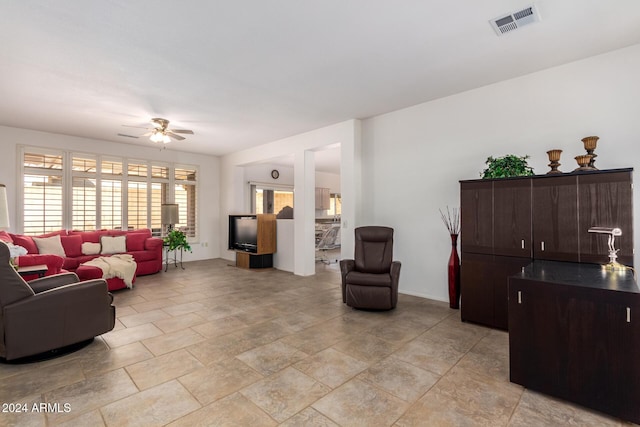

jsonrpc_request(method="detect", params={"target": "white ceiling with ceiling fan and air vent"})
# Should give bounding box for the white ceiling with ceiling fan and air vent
[0,0,640,171]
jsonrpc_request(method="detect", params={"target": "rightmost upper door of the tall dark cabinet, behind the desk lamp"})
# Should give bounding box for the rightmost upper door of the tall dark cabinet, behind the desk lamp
[578,172,633,265]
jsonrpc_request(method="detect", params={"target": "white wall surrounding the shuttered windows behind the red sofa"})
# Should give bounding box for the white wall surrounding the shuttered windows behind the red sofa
[0,126,220,261]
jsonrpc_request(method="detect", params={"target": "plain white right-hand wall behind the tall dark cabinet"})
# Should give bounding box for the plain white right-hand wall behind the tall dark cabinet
[360,45,640,301]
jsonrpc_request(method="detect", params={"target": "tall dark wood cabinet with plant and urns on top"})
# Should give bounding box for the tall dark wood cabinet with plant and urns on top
[460,168,633,330]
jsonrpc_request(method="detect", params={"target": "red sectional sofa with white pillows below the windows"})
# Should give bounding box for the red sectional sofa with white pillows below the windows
[0,229,162,290]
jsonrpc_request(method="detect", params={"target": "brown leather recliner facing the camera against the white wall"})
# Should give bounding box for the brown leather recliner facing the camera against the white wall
[340,226,401,310]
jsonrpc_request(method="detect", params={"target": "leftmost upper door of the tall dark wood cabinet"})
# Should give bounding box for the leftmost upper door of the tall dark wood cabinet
[460,181,493,254]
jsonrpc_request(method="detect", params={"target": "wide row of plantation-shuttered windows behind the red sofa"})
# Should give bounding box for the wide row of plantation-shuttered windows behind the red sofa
[22,147,197,238]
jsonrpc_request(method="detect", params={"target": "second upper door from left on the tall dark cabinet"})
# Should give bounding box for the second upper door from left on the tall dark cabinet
[493,179,532,258]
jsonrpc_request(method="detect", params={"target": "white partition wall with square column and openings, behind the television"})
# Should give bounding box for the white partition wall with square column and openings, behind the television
[220,120,360,275]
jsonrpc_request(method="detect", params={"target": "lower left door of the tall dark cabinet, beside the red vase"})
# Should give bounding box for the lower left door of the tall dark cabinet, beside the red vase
[460,253,494,326]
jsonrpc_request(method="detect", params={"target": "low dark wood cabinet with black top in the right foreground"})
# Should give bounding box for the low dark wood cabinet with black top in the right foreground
[509,261,640,423]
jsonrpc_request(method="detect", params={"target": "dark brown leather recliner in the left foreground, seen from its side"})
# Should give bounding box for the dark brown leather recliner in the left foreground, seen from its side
[0,242,116,360]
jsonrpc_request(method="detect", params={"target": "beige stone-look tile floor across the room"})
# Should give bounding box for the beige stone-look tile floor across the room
[0,260,626,427]
